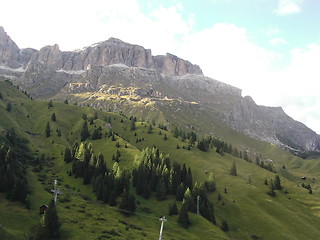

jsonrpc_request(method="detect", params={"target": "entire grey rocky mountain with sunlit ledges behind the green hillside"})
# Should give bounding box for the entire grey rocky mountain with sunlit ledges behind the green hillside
[0,27,320,154]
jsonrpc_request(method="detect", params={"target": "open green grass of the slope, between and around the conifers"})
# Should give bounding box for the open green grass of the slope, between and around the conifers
[0,82,320,239]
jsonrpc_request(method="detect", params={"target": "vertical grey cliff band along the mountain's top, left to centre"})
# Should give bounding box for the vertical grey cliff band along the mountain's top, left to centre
[0,27,202,76]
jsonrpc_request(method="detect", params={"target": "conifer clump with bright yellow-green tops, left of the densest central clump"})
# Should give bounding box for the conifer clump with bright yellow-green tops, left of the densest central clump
[69,142,136,215]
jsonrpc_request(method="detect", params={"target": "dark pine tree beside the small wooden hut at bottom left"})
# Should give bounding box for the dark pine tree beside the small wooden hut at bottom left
[44,200,60,239]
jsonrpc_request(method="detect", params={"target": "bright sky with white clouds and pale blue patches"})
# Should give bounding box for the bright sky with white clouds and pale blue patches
[0,0,320,134]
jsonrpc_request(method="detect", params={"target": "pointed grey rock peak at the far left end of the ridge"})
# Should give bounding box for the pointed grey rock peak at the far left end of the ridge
[0,26,20,68]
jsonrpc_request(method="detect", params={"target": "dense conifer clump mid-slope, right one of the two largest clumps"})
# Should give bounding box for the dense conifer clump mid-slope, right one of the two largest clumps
[132,147,192,201]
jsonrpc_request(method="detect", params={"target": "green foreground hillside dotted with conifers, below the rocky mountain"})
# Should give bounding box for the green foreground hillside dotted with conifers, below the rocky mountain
[0,81,320,240]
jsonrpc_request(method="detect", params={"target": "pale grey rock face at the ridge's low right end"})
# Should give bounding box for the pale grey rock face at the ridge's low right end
[227,97,320,151]
